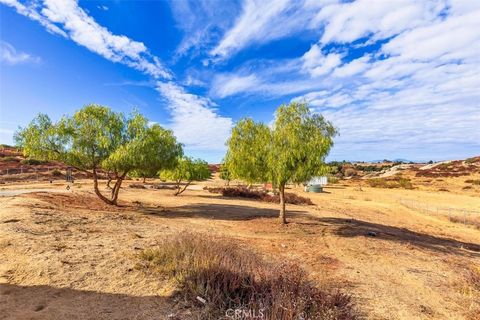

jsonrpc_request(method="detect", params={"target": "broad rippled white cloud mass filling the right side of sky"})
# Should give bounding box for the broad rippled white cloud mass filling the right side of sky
[211,0,480,159]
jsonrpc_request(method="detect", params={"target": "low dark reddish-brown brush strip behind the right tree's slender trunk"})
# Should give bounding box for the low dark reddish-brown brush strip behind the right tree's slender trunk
[207,187,313,205]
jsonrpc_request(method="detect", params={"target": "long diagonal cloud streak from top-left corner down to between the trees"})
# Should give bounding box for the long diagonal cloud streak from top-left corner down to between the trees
[0,0,232,155]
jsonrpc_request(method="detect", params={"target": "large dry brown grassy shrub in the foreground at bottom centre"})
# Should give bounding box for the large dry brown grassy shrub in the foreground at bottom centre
[137,233,359,320]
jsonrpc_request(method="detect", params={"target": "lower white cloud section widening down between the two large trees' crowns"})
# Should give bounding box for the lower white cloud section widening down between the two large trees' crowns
[157,82,232,151]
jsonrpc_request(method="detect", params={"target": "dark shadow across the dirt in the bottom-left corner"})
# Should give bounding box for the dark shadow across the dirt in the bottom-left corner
[0,284,172,320]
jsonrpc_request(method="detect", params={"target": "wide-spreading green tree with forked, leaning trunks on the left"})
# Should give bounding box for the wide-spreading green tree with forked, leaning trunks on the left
[15,104,183,205]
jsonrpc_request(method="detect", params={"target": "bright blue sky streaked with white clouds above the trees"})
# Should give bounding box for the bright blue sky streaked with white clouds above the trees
[0,0,480,162]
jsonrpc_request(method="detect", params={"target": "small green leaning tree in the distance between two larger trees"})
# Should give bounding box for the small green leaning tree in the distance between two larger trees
[159,157,211,196]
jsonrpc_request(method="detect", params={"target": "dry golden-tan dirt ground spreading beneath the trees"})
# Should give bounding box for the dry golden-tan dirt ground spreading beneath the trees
[0,181,480,319]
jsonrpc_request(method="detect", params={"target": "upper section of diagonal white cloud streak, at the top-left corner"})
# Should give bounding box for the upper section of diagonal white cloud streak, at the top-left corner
[0,0,171,79]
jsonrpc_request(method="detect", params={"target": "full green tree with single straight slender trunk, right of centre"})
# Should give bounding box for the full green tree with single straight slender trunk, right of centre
[227,102,337,223]
